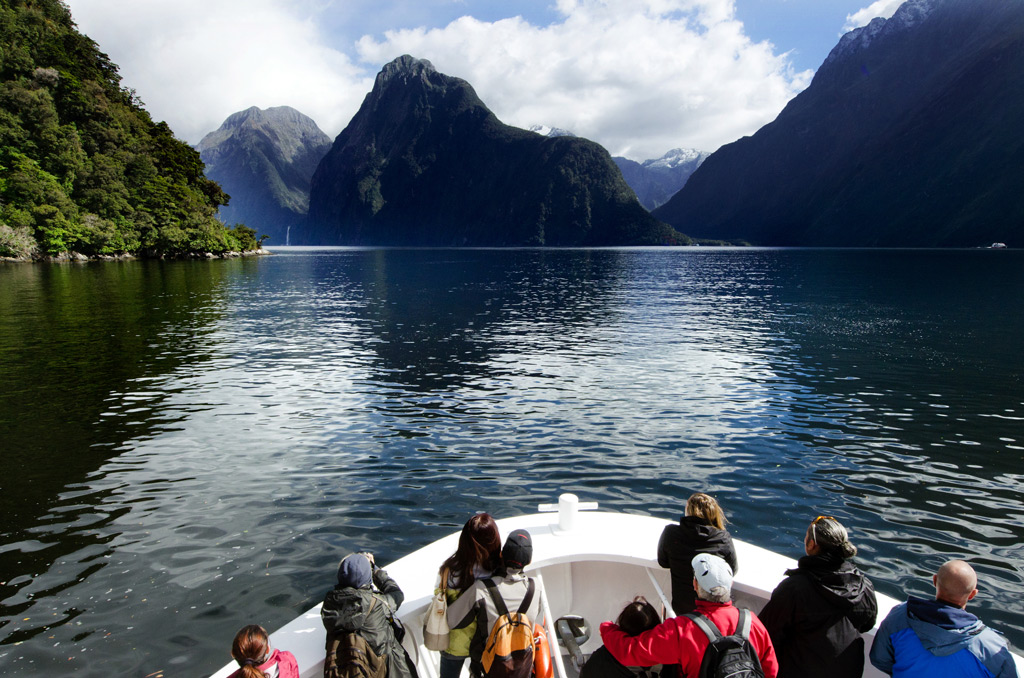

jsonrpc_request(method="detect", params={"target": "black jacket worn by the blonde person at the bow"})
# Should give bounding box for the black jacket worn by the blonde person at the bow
[657,515,738,615]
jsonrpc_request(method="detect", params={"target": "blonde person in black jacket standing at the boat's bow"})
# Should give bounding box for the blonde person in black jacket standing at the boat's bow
[657,492,739,615]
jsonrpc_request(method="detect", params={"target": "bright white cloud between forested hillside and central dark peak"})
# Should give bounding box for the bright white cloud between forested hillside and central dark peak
[68,0,373,143]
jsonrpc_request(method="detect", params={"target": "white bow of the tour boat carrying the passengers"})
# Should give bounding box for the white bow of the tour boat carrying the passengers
[212,495,1024,678]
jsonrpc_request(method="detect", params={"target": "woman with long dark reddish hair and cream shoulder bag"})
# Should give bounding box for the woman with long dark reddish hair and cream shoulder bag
[438,513,502,678]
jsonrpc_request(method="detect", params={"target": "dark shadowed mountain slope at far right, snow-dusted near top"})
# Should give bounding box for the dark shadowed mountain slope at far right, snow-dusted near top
[654,0,1024,247]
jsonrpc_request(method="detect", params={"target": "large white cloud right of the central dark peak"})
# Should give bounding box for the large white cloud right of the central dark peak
[358,0,811,160]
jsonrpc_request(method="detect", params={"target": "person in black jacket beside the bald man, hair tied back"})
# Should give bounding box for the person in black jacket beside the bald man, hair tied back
[758,515,879,678]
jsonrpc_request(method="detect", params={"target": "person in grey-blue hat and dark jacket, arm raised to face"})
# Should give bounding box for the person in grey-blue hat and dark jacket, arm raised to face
[321,553,416,678]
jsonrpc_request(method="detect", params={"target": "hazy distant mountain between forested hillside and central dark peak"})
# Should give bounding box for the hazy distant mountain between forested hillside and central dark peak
[199,107,331,245]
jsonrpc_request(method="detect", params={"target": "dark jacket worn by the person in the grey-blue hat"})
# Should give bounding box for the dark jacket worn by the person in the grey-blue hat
[321,567,416,678]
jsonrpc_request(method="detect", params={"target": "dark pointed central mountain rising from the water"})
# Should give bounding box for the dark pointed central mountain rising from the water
[292,56,685,247]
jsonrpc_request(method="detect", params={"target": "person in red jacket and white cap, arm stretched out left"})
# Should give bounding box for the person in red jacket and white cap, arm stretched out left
[601,553,778,678]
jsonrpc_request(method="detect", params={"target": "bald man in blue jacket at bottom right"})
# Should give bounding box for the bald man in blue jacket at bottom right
[869,560,1017,678]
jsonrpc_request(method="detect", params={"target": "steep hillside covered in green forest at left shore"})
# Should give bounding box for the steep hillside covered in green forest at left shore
[0,0,251,256]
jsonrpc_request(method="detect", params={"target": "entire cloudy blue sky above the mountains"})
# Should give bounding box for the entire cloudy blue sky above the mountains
[68,0,899,160]
